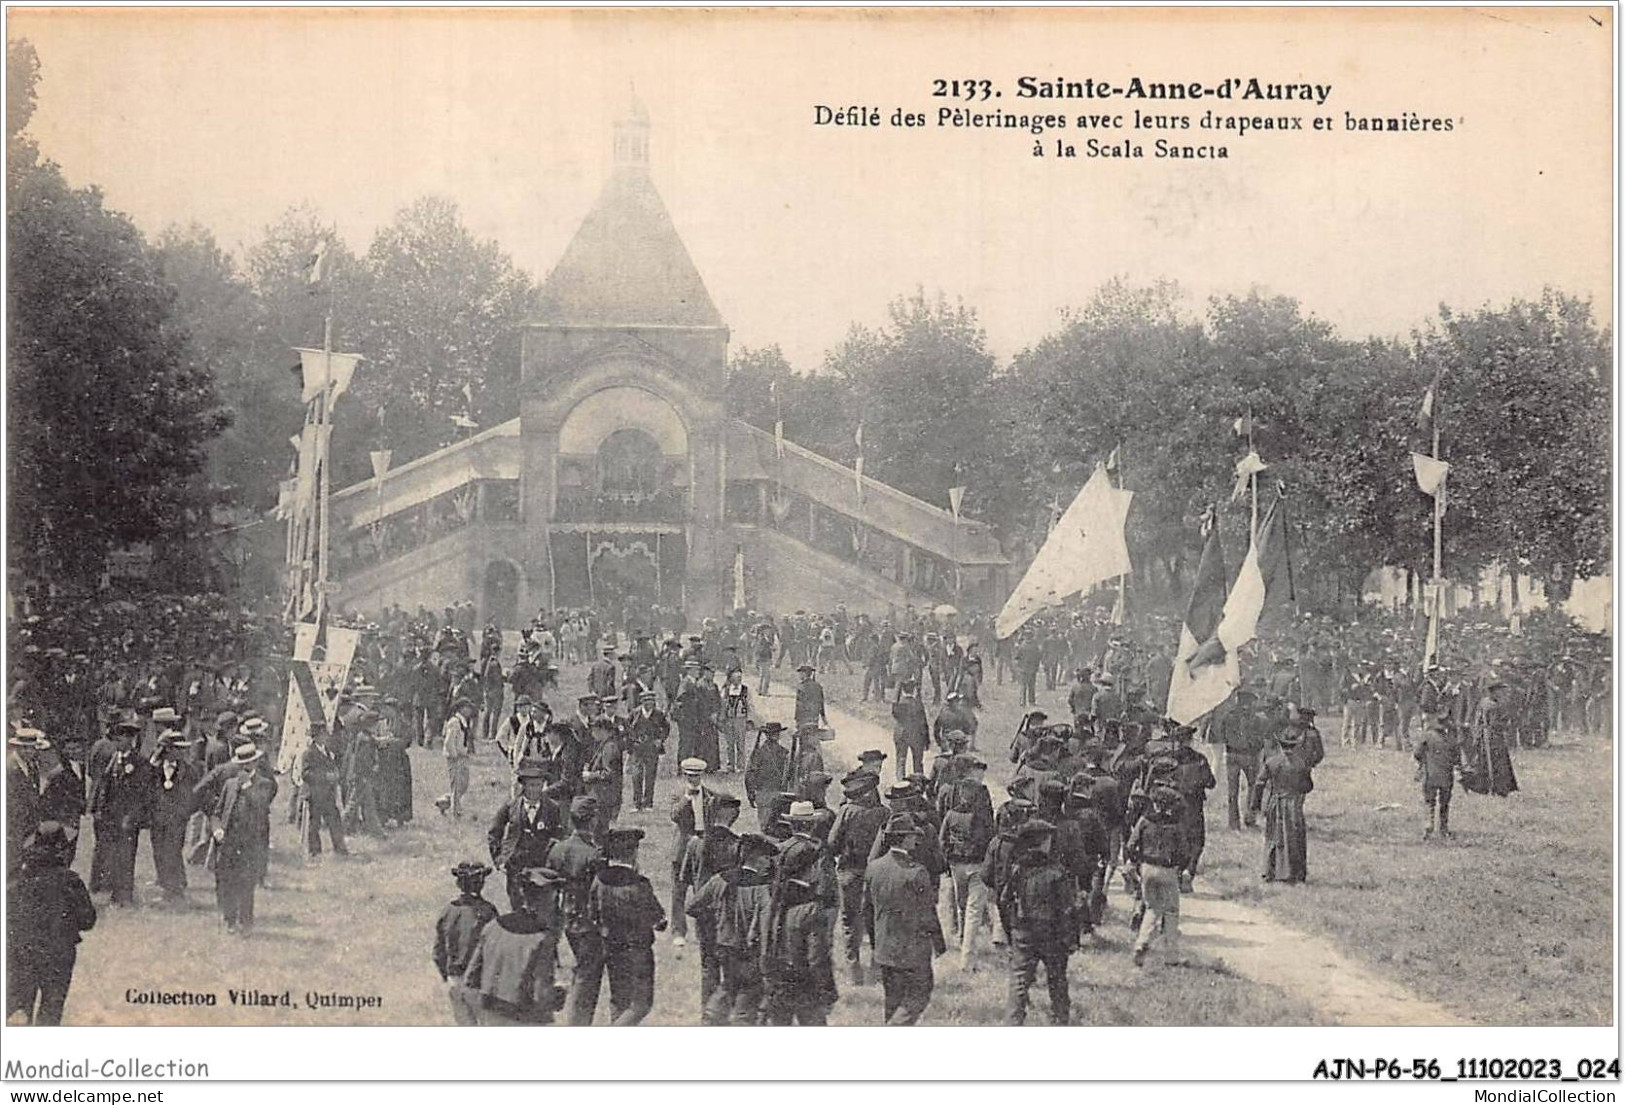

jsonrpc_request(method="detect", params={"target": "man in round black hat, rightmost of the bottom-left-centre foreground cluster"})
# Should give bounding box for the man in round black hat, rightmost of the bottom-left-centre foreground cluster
[587,829,666,1029]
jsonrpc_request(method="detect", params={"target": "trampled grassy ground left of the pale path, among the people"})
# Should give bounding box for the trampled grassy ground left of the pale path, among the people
[47,656,1315,1025]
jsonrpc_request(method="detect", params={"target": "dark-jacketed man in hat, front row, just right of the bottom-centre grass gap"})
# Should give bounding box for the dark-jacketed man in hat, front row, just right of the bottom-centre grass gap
[687,832,778,1025]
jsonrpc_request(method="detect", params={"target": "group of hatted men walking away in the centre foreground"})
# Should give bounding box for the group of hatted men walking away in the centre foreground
[434,646,1324,1025]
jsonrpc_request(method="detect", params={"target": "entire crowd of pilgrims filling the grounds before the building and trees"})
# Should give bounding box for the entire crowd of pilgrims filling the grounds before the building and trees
[7,596,1610,1024]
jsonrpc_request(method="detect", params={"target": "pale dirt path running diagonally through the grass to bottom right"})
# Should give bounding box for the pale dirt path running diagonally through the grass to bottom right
[761,686,1471,1025]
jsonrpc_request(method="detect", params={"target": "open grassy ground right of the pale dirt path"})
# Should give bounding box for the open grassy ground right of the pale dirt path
[821,656,1614,1024]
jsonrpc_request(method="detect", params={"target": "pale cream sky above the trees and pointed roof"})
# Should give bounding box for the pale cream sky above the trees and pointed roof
[8,8,1614,369]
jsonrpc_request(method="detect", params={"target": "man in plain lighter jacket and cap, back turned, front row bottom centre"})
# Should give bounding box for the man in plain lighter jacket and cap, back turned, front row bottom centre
[863,814,947,1025]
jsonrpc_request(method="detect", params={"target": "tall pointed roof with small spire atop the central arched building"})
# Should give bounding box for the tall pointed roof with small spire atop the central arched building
[536,93,725,328]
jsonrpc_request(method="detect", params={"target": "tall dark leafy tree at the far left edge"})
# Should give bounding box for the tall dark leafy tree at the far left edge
[7,44,228,585]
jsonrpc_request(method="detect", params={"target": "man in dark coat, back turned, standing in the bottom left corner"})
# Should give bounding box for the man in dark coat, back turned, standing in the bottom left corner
[5,821,96,1025]
